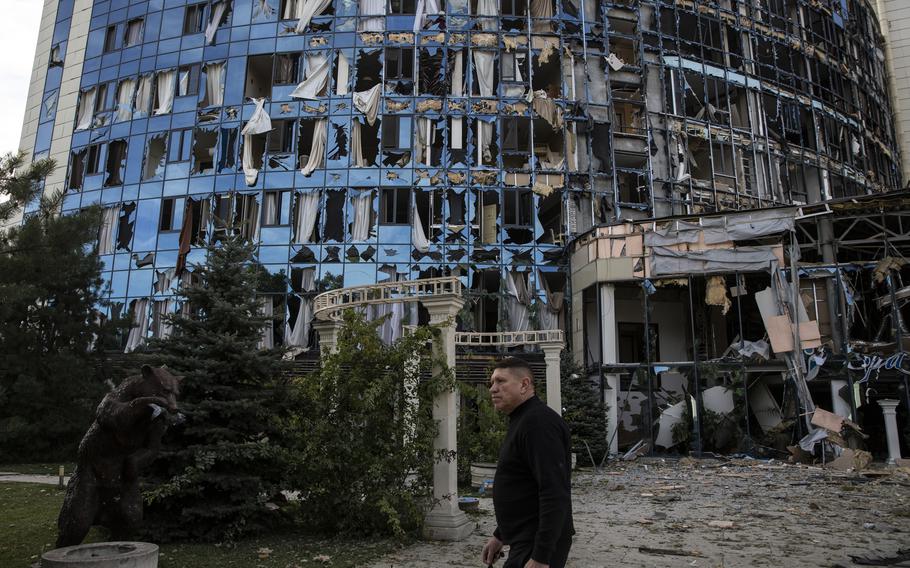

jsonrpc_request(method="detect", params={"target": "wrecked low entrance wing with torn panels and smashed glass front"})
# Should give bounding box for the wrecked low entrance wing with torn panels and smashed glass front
[570,192,910,464]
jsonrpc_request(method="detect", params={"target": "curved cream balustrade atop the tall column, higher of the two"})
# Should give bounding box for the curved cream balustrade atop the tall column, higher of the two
[314,276,462,321]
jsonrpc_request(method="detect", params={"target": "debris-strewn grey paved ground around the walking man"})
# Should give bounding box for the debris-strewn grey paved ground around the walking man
[371,459,910,568]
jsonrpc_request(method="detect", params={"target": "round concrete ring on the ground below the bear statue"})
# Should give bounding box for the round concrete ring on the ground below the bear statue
[41,542,158,568]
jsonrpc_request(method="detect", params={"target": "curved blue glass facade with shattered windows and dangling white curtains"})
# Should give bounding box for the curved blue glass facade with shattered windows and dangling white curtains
[34,0,900,352]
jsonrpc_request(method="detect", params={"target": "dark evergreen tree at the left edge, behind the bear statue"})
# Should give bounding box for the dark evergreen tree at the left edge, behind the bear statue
[0,155,117,461]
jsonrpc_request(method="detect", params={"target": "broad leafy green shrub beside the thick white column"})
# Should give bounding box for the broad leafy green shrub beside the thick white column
[292,312,454,537]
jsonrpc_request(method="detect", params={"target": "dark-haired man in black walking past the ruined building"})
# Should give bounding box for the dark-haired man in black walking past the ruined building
[482,357,575,568]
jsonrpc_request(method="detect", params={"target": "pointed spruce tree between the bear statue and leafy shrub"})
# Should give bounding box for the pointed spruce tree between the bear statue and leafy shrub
[145,238,291,541]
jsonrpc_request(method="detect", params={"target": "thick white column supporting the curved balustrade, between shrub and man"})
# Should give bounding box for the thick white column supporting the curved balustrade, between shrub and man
[421,296,475,541]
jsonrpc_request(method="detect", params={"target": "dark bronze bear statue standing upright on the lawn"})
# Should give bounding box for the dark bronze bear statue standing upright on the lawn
[57,365,182,548]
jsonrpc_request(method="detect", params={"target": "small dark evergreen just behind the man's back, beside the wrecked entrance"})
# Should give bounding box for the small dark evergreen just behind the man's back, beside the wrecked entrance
[560,351,608,466]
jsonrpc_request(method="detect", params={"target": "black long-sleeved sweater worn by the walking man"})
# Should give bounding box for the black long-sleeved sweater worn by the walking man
[493,396,575,564]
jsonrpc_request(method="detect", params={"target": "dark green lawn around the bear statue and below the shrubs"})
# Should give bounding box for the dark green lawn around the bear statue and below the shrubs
[0,483,395,568]
